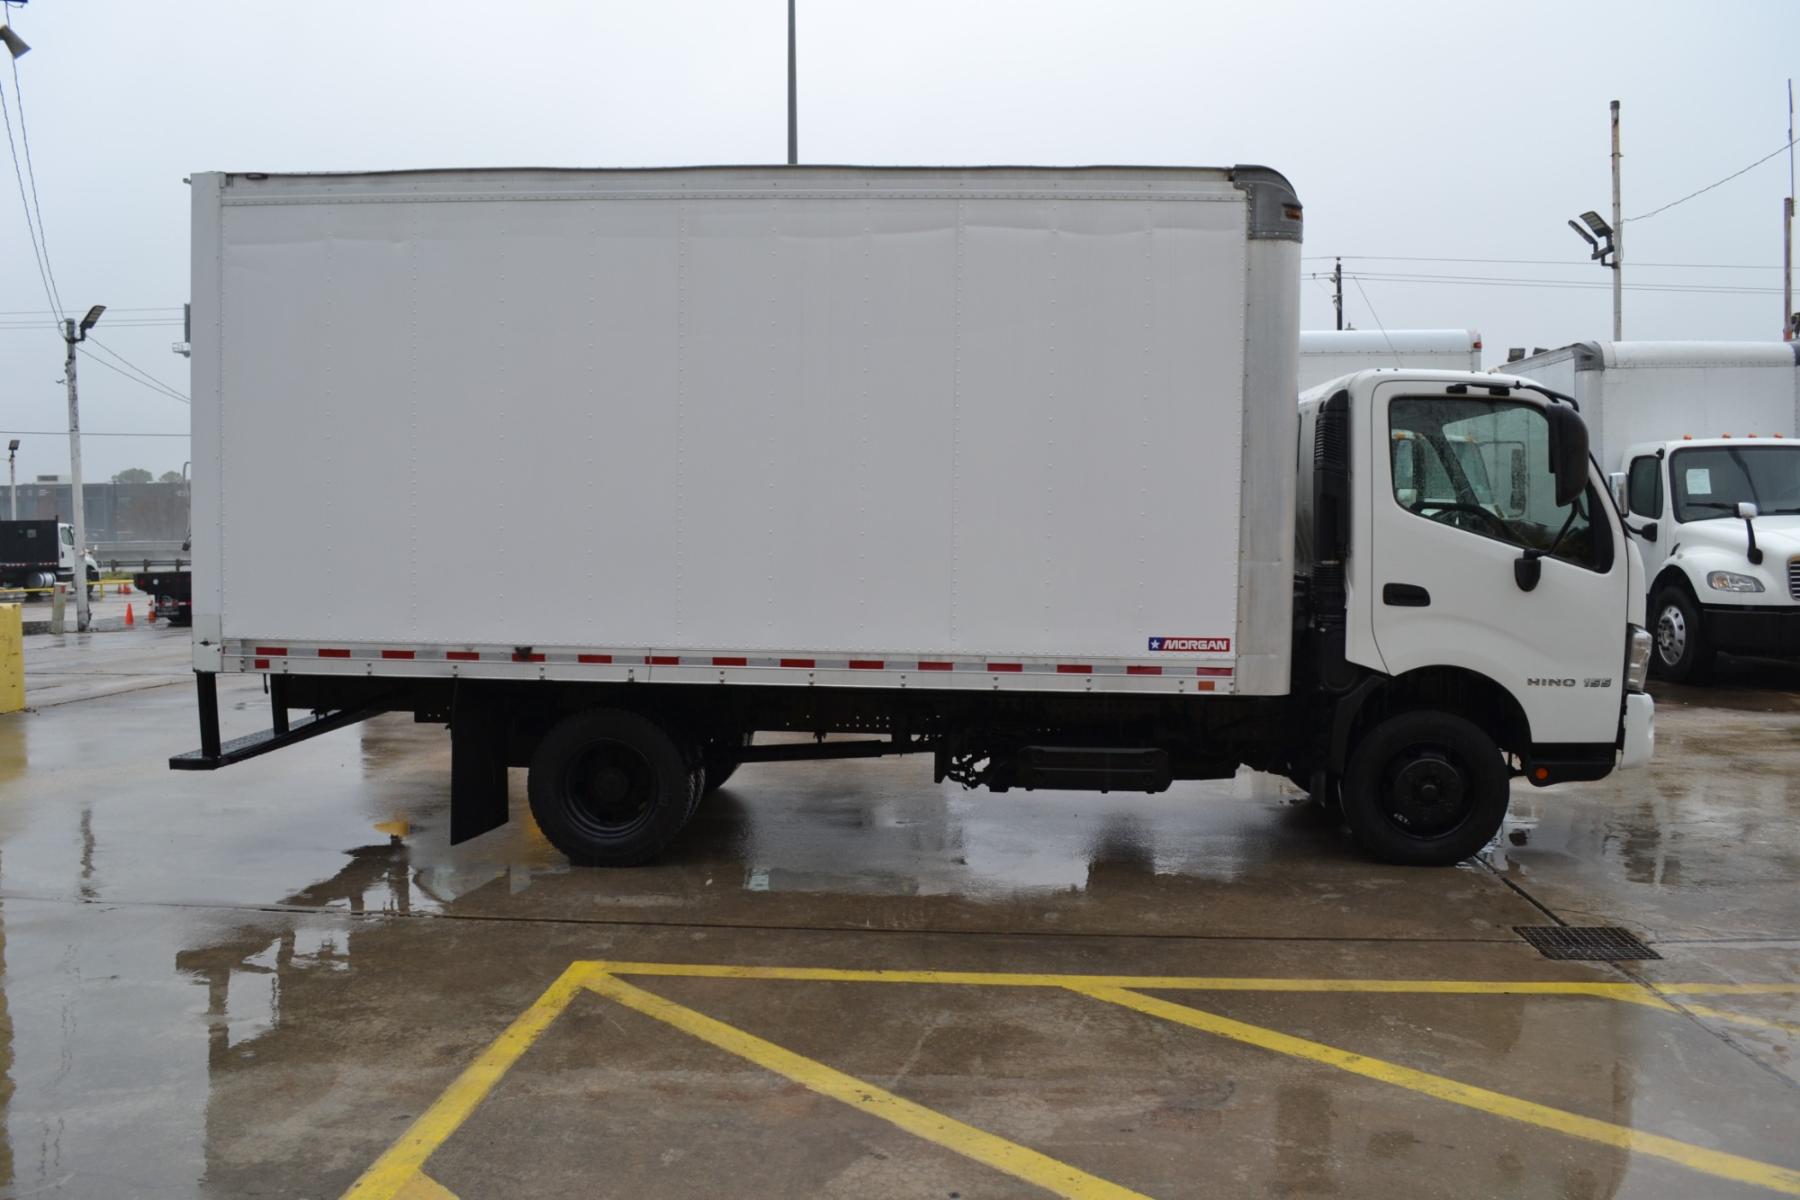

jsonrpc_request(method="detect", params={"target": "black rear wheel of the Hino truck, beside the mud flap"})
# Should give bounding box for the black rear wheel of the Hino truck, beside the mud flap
[526,709,704,867]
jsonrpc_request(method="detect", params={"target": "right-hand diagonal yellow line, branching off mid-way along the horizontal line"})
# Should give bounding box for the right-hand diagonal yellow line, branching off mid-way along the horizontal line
[1073,988,1800,1196]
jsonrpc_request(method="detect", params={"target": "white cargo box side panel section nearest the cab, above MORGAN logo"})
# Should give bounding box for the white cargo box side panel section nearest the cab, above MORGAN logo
[954,193,1246,660]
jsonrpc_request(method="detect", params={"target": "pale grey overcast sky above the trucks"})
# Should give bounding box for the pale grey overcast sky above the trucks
[0,0,1800,479]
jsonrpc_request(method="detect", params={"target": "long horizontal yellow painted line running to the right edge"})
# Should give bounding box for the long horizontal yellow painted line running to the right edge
[589,963,1800,1011]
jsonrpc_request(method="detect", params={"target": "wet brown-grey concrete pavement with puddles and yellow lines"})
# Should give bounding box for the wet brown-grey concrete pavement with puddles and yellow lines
[0,630,1800,1200]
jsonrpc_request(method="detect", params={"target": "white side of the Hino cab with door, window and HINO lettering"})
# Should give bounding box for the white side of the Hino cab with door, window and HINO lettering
[1366,381,1627,743]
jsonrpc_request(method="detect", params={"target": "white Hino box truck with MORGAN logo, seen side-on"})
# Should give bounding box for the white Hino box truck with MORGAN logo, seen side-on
[171,167,1652,865]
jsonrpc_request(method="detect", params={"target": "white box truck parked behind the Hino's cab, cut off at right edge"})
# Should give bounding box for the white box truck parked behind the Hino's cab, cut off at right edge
[1505,342,1800,682]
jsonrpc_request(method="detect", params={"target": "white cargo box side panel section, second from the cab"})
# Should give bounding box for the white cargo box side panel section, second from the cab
[673,193,956,657]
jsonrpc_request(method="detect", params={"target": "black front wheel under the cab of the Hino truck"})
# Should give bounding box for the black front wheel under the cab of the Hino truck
[1339,711,1510,867]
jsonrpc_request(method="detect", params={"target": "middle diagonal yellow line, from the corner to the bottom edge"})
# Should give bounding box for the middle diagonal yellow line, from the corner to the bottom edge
[587,972,1145,1200]
